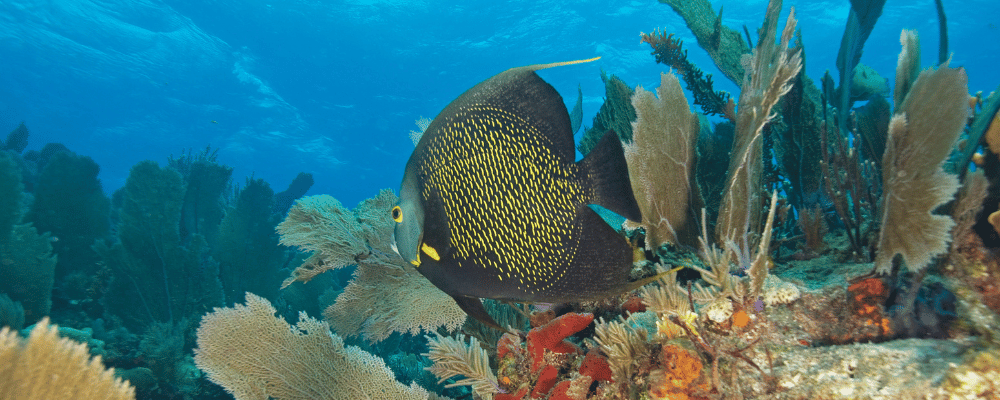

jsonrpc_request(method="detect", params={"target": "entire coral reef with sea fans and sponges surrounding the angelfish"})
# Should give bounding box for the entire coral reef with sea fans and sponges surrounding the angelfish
[0,0,1000,400]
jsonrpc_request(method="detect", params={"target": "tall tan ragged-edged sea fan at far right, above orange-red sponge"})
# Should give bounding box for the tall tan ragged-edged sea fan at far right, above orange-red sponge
[875,66,969,273]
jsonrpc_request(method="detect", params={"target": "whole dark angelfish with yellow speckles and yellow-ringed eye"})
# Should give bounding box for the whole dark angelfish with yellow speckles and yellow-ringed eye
[392,58,651,329]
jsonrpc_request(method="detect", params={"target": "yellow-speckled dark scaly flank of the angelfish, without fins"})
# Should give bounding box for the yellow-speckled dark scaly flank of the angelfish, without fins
[419,105,583,293]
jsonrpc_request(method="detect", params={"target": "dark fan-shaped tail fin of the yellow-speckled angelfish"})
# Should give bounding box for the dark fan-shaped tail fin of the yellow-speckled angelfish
[580,130,642,221]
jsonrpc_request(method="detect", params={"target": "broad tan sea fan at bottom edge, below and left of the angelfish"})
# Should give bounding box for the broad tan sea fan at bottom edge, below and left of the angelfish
[194,293,428,400]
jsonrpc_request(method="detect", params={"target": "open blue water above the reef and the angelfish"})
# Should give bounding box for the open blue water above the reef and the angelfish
[0,0,1000,205]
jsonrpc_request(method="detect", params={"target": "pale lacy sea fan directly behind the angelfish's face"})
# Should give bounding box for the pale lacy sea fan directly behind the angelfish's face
[278,190,465,342]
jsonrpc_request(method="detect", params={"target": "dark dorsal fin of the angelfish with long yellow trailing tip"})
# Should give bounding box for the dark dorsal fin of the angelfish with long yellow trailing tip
[428,57,600,162]
